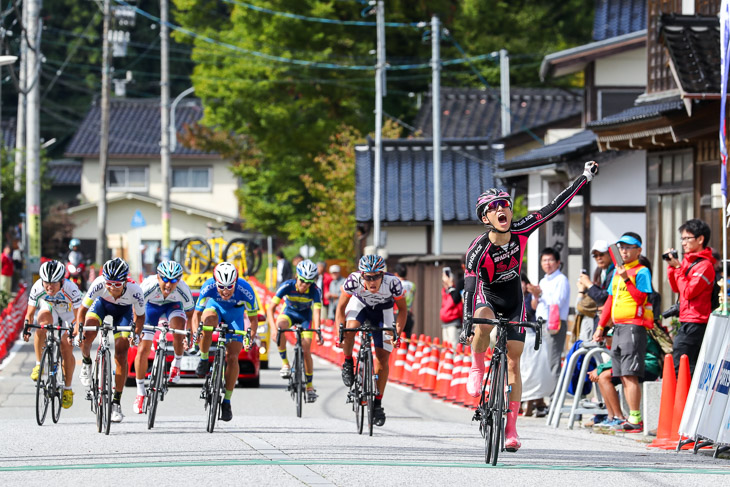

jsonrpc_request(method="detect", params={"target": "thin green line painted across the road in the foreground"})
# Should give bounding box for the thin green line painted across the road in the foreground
[0,460,730,475]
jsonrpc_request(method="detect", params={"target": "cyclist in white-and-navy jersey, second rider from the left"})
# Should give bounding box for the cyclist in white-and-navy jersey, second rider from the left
[76,257,145,423]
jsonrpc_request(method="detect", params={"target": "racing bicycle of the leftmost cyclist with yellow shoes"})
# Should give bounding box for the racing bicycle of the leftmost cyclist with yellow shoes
[23,317,73,426]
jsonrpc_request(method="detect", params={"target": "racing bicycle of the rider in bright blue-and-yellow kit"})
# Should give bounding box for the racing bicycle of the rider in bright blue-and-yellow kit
[194,322,251,433]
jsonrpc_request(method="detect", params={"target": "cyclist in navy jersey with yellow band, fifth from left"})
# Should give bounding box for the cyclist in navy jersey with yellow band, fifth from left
[266,259,322,402]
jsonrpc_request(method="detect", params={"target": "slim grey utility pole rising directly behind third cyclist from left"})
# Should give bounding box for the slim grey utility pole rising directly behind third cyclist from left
[160,0,170,260]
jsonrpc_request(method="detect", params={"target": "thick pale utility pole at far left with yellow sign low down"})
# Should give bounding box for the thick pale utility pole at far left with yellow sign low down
[25,0,41,282]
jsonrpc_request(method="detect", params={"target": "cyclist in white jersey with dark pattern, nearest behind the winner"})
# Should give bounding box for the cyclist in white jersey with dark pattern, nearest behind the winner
[335,255,408,426]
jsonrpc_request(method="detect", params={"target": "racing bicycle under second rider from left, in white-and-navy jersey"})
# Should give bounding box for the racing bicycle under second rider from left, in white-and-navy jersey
[81,321,134,435]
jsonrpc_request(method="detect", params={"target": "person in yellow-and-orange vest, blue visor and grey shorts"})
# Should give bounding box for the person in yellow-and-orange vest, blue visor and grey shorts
[593,232,654,433]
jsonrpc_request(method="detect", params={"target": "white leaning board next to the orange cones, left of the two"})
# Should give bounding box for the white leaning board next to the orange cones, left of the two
[679,314,728,439]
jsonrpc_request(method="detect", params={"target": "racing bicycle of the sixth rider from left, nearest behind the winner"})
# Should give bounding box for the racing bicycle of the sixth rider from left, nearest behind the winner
[340,321,396,436]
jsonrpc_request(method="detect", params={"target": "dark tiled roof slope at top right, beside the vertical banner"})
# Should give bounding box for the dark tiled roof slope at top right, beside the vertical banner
[661,14,722,93]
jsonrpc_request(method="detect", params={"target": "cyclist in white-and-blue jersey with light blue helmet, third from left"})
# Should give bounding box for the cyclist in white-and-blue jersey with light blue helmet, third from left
[134,260,195,414]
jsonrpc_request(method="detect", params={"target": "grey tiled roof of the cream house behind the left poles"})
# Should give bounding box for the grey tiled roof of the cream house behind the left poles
[66,98,213,157]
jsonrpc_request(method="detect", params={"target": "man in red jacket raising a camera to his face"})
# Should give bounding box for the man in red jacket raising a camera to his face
[662,218,715,374]
